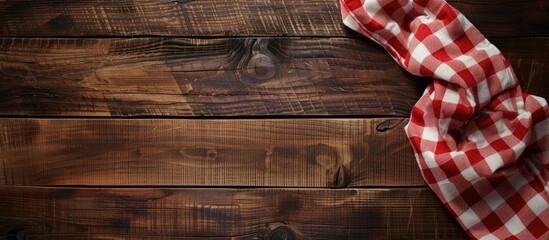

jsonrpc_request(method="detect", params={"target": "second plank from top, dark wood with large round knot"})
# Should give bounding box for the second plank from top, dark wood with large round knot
[0,38,549,117]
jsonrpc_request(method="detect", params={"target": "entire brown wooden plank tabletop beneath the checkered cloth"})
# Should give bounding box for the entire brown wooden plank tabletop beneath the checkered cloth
[0,0,549,240]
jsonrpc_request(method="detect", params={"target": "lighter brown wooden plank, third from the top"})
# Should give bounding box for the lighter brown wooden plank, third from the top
[0,118,425,187]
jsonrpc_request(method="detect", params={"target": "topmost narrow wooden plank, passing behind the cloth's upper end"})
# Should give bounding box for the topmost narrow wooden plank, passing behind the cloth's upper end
[0,0,549,37]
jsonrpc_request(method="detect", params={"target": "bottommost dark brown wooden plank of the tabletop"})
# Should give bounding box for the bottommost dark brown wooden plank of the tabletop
[0,186,466,240]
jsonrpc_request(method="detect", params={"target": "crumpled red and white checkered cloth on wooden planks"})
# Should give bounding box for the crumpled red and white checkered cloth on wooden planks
[341,0,549,239]
